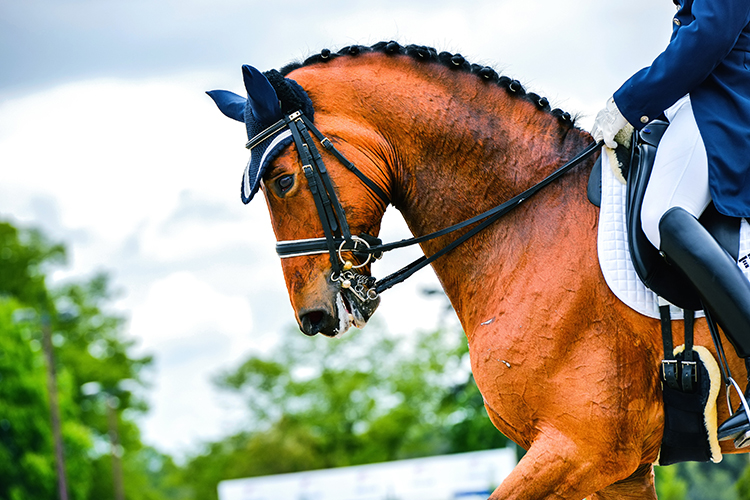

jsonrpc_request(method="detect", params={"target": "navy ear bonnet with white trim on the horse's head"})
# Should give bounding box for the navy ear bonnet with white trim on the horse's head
[206,65,314,204]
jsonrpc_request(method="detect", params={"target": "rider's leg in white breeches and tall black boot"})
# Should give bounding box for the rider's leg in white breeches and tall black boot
[641,97,750,446]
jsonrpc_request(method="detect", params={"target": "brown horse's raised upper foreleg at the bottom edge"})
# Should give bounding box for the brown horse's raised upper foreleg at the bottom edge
[490,429,656,500]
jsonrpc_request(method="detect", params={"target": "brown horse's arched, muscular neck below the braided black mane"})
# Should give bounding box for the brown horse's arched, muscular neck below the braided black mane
[294,55,596,333]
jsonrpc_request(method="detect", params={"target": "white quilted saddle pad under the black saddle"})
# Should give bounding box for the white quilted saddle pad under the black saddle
[597,151,750,319]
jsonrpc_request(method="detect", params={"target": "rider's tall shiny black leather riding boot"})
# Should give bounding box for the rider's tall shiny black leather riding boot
[659,207,750,447]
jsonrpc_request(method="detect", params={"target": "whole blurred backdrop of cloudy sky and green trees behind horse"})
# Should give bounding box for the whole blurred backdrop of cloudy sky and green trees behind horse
[0,0,750,500]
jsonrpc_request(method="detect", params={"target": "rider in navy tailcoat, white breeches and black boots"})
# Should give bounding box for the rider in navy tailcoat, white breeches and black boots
[592,0,750,447]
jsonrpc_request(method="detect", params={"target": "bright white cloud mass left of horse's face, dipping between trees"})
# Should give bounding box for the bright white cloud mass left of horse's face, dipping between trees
[0,73,293,452]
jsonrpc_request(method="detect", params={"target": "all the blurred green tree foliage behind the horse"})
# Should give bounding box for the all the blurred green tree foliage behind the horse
[7,222,750,500]
